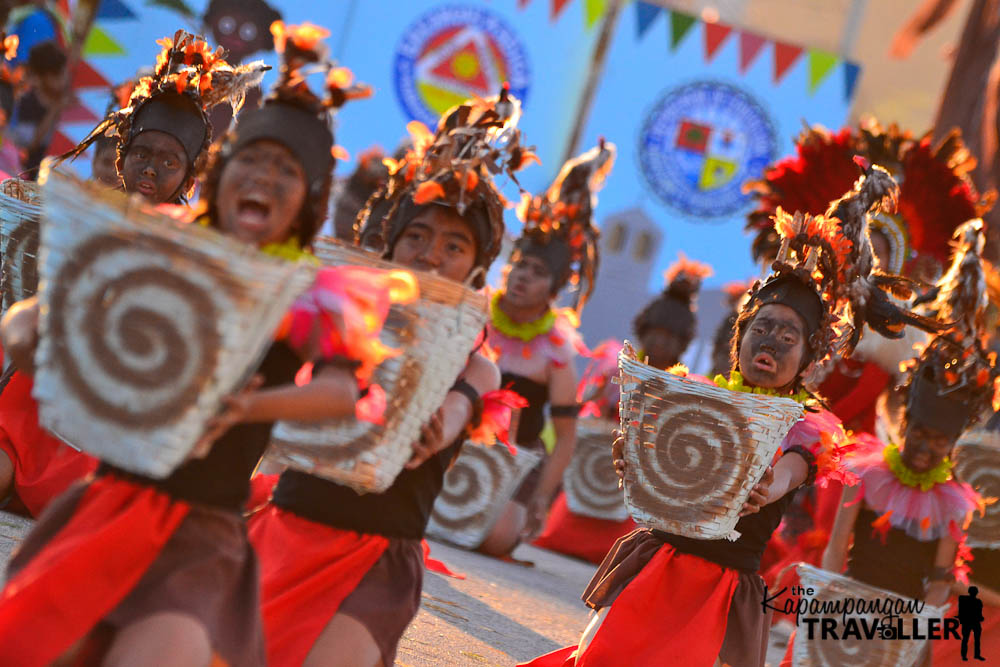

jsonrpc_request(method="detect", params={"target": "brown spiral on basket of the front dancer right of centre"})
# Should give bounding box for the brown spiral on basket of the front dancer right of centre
[629,396,750,521]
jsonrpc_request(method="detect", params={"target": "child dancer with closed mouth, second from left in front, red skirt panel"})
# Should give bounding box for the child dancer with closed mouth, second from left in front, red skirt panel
[250,85,536,667]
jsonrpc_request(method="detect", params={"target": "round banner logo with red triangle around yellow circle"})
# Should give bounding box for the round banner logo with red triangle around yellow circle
[394,6,531,127]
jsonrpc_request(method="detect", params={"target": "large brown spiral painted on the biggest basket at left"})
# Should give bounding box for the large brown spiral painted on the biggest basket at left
[48,234,227,428]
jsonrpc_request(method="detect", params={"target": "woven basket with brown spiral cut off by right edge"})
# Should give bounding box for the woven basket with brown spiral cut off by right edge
[952,429,1000,549]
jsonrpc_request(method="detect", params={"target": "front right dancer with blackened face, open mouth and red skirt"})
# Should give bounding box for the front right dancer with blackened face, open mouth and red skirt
[528,162,940,667]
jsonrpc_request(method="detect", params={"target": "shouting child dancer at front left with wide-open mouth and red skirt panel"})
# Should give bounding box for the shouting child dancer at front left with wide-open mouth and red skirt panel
[0,26,378,665]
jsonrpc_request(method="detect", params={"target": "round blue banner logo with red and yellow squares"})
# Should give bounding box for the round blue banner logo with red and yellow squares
[639,81,777,218]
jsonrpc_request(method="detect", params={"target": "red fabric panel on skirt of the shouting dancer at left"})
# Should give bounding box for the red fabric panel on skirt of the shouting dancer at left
[0,476,189,667]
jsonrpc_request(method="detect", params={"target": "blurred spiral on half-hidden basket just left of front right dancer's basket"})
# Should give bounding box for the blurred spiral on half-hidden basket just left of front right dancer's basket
[563,435,625,518]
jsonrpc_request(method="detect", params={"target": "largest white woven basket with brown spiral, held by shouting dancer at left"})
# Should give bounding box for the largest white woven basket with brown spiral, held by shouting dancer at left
[34,172,315,477]
